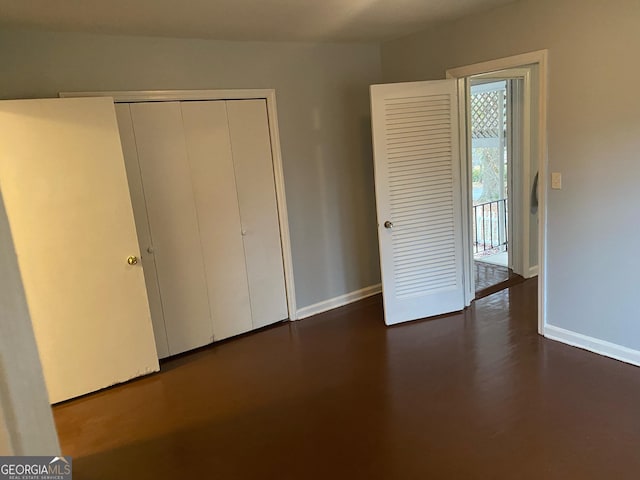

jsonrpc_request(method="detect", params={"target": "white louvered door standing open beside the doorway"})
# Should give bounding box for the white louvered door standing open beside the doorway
[371,80,464,325]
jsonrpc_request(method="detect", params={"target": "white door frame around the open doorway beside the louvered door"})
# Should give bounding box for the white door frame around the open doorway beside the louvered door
[446,50,548,335]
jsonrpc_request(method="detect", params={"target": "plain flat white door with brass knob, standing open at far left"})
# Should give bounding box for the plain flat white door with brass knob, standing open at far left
[0,98,158,403]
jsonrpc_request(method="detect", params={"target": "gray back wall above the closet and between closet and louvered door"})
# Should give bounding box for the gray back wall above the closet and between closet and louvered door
[0,30,381,308]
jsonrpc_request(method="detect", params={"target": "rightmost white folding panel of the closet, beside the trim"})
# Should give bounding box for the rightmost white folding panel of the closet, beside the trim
[226,100,288,328]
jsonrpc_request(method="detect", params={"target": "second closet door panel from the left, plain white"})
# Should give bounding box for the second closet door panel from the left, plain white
[130,102,213,355]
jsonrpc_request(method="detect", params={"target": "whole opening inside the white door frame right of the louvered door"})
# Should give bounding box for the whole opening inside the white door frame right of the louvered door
[464,64,539,298]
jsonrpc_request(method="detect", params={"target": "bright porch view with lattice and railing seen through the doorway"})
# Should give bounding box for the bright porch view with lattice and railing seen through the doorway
[468,75,525,298]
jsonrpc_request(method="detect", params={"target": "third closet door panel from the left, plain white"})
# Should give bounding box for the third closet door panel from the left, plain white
[182,101,253,340]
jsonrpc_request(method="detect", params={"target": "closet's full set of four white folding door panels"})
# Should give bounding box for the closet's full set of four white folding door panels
[116,99,288,358]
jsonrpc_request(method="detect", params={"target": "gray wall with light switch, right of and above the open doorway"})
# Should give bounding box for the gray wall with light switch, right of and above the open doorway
[382,0,640,350]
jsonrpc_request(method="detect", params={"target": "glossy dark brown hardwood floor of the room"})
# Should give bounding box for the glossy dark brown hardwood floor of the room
[54,280,640,480]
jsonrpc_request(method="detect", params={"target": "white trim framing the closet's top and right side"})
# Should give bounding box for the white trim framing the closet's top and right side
[59,89,297,320]
